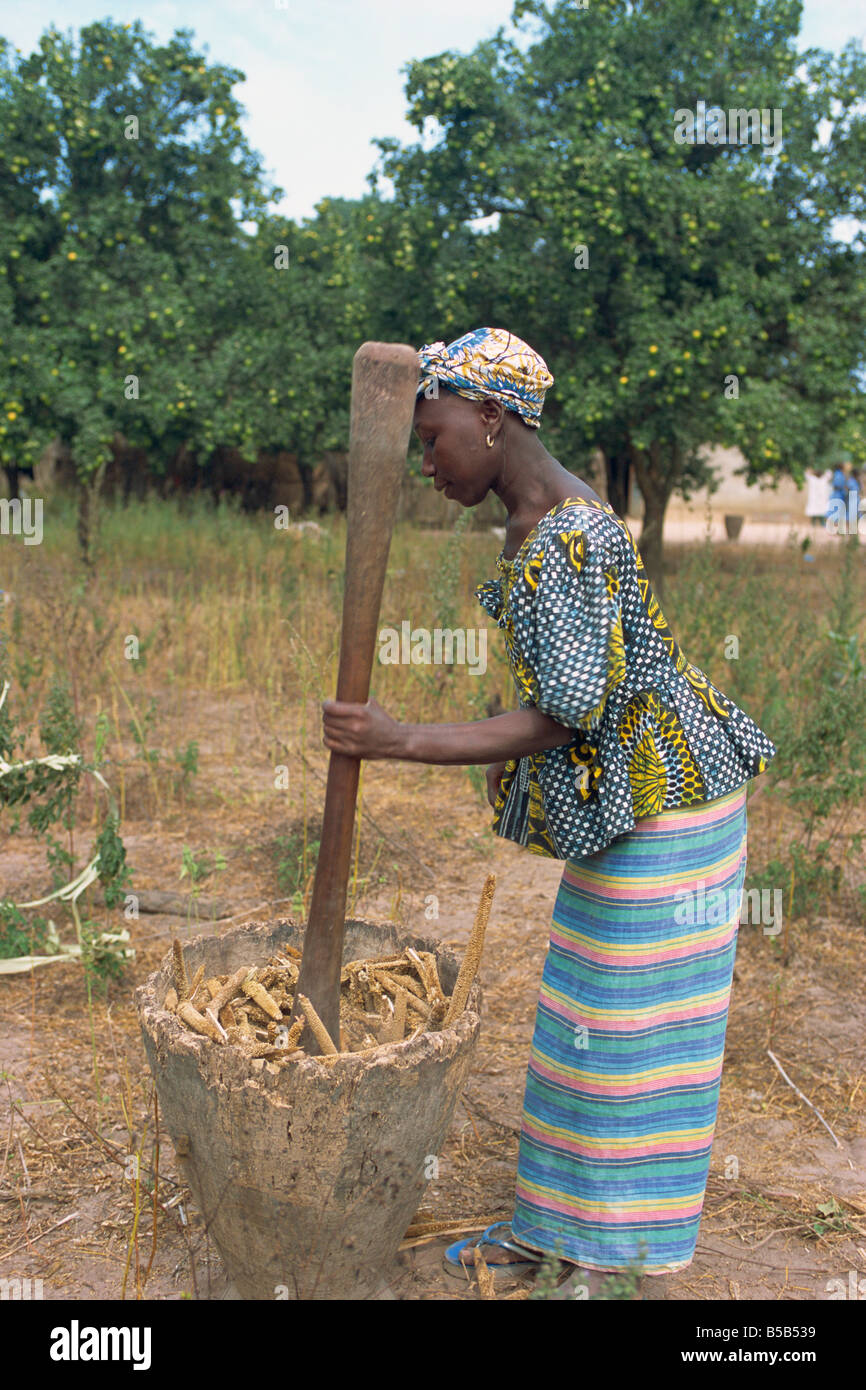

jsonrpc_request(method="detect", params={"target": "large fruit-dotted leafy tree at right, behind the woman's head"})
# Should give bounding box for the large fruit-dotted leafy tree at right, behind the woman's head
[377,0,866,582]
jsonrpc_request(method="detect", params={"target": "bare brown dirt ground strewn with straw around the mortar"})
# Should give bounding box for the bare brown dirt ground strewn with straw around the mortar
[0,695,866,1301]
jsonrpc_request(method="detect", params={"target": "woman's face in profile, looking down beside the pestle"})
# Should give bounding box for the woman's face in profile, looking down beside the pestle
[414,386,505,507]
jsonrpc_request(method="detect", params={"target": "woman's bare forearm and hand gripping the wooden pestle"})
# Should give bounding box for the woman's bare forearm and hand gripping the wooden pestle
[322,699,574,766]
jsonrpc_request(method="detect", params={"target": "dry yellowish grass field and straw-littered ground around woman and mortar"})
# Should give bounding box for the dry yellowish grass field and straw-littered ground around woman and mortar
[0,494,866,1298]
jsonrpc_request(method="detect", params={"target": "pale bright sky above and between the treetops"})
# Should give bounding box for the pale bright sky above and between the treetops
[0,0,866,220]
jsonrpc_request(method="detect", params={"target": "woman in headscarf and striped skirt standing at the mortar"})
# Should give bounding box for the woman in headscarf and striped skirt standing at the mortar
[322,328,776,1273]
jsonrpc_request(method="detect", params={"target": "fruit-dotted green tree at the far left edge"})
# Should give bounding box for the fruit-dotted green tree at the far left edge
[0,21,276,556]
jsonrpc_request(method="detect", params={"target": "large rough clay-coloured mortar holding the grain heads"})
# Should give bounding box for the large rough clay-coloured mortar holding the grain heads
[135,920,481,1300]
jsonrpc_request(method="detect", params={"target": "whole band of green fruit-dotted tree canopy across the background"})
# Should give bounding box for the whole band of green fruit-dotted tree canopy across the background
[0,0,866,574]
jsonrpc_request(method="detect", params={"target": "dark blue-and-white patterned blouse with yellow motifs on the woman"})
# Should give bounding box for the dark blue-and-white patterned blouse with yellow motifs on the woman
[475,498,776,859]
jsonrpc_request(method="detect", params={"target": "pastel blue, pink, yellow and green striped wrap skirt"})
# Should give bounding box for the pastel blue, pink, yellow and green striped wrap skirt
[512,785,746,1275]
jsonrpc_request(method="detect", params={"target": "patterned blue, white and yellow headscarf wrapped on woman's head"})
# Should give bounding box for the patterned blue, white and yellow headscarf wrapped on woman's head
[417,328,553,430]
